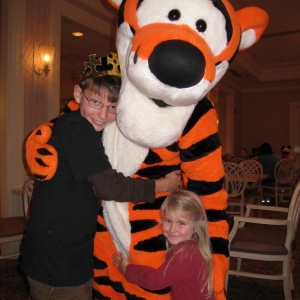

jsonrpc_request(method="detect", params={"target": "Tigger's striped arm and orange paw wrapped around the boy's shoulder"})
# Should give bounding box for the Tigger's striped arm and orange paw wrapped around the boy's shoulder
[25,101,78,181]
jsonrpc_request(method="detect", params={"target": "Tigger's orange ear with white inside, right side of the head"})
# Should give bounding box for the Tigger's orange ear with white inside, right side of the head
[236,6,269,51]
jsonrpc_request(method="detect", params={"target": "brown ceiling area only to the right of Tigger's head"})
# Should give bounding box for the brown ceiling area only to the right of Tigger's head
[222,0,300,92]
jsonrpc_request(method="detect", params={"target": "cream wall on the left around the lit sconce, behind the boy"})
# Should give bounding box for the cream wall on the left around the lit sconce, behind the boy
[0,0,115,252]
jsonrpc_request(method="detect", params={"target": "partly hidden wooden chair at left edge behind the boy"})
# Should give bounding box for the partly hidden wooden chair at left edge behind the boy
[0,180,34,259]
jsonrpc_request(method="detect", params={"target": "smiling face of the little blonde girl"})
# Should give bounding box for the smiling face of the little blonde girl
[162,210,194,245]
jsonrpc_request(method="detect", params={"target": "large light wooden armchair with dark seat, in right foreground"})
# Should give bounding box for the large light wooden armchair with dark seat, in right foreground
[226,183,300,300]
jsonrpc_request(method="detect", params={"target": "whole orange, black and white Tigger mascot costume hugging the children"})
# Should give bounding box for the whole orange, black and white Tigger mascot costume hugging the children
[26,0,268,300]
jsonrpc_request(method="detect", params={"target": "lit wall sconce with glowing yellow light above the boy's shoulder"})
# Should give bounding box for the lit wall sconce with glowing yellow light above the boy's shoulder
[34,42,54,76]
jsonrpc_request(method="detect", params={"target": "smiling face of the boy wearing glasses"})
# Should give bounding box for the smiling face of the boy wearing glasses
[74,85,117,131]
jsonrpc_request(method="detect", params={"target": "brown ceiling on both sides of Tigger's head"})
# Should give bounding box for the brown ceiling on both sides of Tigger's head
[61,0,300,92]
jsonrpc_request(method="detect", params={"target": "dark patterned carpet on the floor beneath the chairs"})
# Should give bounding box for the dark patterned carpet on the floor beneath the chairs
[0,207,300,300]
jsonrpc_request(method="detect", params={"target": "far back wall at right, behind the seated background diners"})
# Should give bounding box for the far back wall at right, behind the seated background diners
[235,89,300,158]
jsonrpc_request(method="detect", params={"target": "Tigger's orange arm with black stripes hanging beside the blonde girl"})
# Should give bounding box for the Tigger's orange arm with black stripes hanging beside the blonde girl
[179,99,229,300]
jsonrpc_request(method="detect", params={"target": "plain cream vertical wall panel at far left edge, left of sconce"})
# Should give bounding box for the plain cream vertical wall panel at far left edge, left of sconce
[0,0,25,216]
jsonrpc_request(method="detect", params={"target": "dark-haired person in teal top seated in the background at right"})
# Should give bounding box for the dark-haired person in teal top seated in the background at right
[257,143,279,183]
